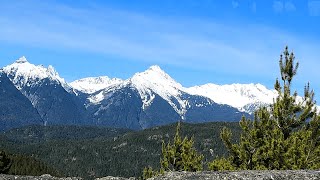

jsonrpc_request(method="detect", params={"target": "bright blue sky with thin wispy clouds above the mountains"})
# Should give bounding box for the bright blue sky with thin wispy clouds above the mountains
[0,0,320,98]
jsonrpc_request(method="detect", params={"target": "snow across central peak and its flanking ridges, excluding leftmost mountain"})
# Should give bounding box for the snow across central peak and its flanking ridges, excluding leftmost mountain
[80,65,277,118]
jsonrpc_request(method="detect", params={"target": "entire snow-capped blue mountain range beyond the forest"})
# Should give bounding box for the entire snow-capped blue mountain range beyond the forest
[0,57,276,130]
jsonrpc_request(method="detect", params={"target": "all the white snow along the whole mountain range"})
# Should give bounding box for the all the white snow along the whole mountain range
[3,56,276,117]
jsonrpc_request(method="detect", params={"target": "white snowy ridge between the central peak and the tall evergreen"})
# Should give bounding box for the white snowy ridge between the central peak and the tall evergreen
[186,83,277,113]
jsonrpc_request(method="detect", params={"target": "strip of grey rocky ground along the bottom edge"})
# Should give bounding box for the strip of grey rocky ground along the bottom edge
[0,170,320,180]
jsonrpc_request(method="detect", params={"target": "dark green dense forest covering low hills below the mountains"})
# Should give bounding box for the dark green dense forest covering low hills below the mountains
[0,122,240,179]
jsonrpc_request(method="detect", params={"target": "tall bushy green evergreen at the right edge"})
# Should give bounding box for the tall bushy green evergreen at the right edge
[209,47,320,170]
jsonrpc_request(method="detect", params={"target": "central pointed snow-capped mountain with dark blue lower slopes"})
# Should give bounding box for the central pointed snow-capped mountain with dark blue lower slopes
[85,66,245,129]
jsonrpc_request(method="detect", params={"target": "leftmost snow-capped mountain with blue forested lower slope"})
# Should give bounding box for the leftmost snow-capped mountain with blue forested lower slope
[2,57,85,124]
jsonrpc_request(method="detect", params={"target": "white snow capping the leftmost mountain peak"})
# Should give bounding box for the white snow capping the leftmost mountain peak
[3,56,70,91]
